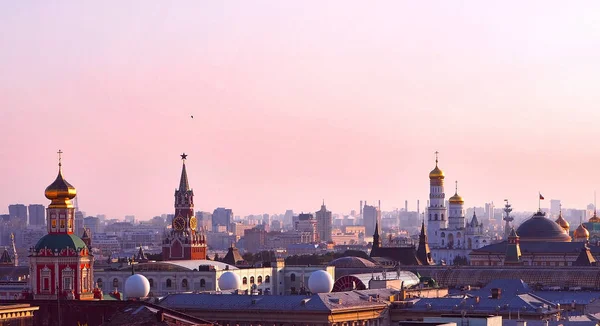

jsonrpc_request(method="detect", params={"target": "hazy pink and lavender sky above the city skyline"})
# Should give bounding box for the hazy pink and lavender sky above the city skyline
[0,0,600,219]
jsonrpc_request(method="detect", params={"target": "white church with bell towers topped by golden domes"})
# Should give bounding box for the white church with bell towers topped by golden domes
[426,153,491,265]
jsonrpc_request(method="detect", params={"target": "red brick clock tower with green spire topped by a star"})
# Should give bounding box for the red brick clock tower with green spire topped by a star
[163,153,206,260]
